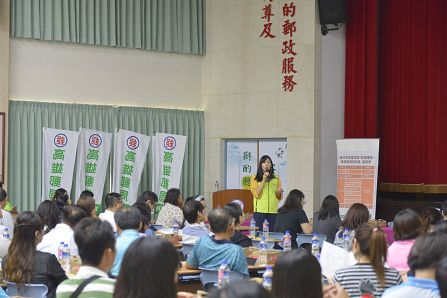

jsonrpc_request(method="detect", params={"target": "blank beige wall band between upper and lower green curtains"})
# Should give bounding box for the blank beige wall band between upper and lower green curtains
[10,39,203,109]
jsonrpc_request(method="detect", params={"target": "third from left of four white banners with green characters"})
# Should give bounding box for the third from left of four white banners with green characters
[112,129,151,205]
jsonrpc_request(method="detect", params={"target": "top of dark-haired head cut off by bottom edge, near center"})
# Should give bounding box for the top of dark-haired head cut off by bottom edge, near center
[208,280,272,298]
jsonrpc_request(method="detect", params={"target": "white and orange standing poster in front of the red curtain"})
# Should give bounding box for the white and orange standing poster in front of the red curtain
[337,139,379,218]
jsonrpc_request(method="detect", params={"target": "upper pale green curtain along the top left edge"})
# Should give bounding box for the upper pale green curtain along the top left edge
[11,0,206,54]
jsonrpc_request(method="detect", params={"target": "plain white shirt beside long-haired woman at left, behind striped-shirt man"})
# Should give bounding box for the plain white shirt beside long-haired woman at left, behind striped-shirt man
[37,223,78,258]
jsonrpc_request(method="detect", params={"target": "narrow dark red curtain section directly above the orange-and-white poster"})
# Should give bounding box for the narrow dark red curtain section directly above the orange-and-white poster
[345,0,378,138]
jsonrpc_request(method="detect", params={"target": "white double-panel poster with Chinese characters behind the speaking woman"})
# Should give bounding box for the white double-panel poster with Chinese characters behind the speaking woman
[225,139,287,198]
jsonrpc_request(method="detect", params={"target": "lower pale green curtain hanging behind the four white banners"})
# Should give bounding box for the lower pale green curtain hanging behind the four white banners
[7,101,205,211]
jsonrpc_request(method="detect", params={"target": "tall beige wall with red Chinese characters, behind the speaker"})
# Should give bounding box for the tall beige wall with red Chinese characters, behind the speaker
[202,0,321,216]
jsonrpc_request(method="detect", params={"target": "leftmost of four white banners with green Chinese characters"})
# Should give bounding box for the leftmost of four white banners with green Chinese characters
[42,127,79,200]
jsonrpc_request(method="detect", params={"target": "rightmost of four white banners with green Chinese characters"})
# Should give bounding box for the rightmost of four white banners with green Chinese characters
[152,133,186,202]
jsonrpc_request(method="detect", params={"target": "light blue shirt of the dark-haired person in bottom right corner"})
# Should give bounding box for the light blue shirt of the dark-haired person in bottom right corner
[382,276,440,298]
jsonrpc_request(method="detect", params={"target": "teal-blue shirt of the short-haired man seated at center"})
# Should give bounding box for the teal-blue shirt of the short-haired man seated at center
[187,236,248,276]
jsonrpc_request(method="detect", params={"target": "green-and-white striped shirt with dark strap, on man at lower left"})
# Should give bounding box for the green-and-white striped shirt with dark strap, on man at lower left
[56,266,115,298]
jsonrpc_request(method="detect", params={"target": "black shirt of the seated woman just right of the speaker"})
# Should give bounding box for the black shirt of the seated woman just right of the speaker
[275,209,309,247]
